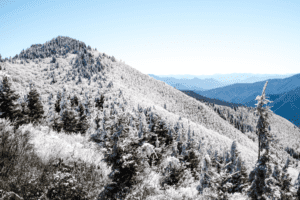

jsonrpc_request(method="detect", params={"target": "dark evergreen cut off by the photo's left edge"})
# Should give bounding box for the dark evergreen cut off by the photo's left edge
[0,76,20,121]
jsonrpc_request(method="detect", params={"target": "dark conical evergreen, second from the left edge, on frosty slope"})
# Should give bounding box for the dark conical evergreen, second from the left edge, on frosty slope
[27,84,44,124]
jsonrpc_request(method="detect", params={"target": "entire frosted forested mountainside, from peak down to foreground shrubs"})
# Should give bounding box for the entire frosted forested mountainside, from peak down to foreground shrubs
[0,36,300,200]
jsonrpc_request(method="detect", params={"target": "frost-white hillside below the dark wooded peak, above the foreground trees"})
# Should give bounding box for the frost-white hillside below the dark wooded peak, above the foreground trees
[0,39,257,169]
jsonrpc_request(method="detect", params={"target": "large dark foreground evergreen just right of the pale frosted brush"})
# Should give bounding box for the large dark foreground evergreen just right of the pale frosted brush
[99,114,147,200]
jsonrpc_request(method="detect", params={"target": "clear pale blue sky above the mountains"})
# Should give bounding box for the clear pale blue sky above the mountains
[0,0,300,75]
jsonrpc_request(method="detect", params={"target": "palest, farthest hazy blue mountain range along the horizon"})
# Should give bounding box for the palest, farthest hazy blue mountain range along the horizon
[148,73,293,91]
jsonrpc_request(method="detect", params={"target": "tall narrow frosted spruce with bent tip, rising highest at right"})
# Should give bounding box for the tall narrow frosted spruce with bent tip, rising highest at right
[248,81,272,200]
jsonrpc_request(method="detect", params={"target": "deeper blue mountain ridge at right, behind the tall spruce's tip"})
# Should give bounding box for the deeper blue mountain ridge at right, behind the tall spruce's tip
[194,74,300,126]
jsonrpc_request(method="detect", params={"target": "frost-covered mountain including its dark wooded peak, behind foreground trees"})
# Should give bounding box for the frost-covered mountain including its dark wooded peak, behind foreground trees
[1,37,300,198]
